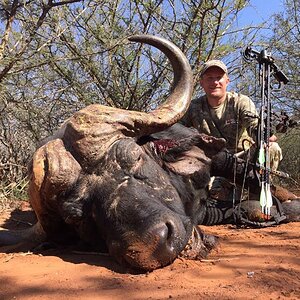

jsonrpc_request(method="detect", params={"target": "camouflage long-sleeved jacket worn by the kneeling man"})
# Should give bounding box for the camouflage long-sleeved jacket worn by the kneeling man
[180,92,258,152]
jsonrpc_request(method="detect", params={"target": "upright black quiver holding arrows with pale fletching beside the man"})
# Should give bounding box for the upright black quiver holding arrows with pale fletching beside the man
[243,47,288,219]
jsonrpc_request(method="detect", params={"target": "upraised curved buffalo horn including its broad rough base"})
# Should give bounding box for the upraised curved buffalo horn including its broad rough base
[63,35,193,166]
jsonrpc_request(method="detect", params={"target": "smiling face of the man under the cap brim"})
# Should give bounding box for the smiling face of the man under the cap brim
[200,67,229,99]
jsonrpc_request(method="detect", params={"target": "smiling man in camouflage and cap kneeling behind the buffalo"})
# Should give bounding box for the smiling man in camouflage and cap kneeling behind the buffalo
[181,60,296,225]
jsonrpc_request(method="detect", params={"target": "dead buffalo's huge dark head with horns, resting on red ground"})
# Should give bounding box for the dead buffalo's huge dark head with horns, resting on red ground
[0,35,298,270]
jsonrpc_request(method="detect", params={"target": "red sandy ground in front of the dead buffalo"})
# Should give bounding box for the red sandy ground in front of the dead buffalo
[0,202,300,300]
